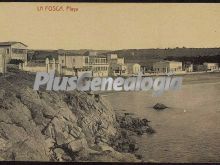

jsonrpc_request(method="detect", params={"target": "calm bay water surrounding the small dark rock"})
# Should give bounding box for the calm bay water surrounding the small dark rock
[106,76,220,162]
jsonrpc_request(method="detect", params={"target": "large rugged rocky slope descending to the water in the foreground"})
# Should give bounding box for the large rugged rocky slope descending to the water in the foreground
[0,67,154,162]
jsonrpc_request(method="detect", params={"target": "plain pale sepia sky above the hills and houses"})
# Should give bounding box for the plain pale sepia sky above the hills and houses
[0,2,220,50]
